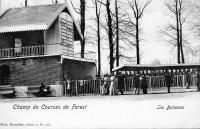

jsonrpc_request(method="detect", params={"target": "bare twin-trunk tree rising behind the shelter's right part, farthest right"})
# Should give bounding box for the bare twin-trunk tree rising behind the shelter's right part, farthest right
[161,0,190,64]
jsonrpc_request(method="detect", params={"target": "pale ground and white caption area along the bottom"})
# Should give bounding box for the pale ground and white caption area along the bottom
[0,92,200,129]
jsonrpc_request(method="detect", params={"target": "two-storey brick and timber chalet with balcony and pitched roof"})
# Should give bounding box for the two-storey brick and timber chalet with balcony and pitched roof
[0,3,96,86]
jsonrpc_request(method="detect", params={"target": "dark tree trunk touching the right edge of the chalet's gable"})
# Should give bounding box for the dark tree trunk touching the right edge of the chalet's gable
[80,0,85,58]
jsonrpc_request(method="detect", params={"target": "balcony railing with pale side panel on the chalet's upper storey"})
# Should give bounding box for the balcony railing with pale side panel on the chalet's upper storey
[0,44,96,60]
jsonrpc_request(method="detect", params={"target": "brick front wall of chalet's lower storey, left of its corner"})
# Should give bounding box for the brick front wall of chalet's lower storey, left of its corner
[0,56,61,86]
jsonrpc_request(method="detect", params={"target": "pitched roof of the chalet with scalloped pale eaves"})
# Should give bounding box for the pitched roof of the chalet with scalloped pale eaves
[0,3,82,37]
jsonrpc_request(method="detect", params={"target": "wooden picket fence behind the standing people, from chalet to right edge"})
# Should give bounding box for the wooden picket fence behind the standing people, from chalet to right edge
[64,75,197,96]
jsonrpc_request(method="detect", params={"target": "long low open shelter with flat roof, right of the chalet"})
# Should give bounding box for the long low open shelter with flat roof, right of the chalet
[113,64,200,93]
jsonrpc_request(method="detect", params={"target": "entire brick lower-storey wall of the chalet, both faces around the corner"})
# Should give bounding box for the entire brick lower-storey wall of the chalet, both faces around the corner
[0,56,96,86]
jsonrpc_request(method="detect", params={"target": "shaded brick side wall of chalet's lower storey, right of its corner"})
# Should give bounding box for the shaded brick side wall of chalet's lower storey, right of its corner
[63,59,96,80]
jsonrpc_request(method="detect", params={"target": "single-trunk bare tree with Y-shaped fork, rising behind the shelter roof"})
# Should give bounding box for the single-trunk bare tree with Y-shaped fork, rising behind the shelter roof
[128,0,152,64]
